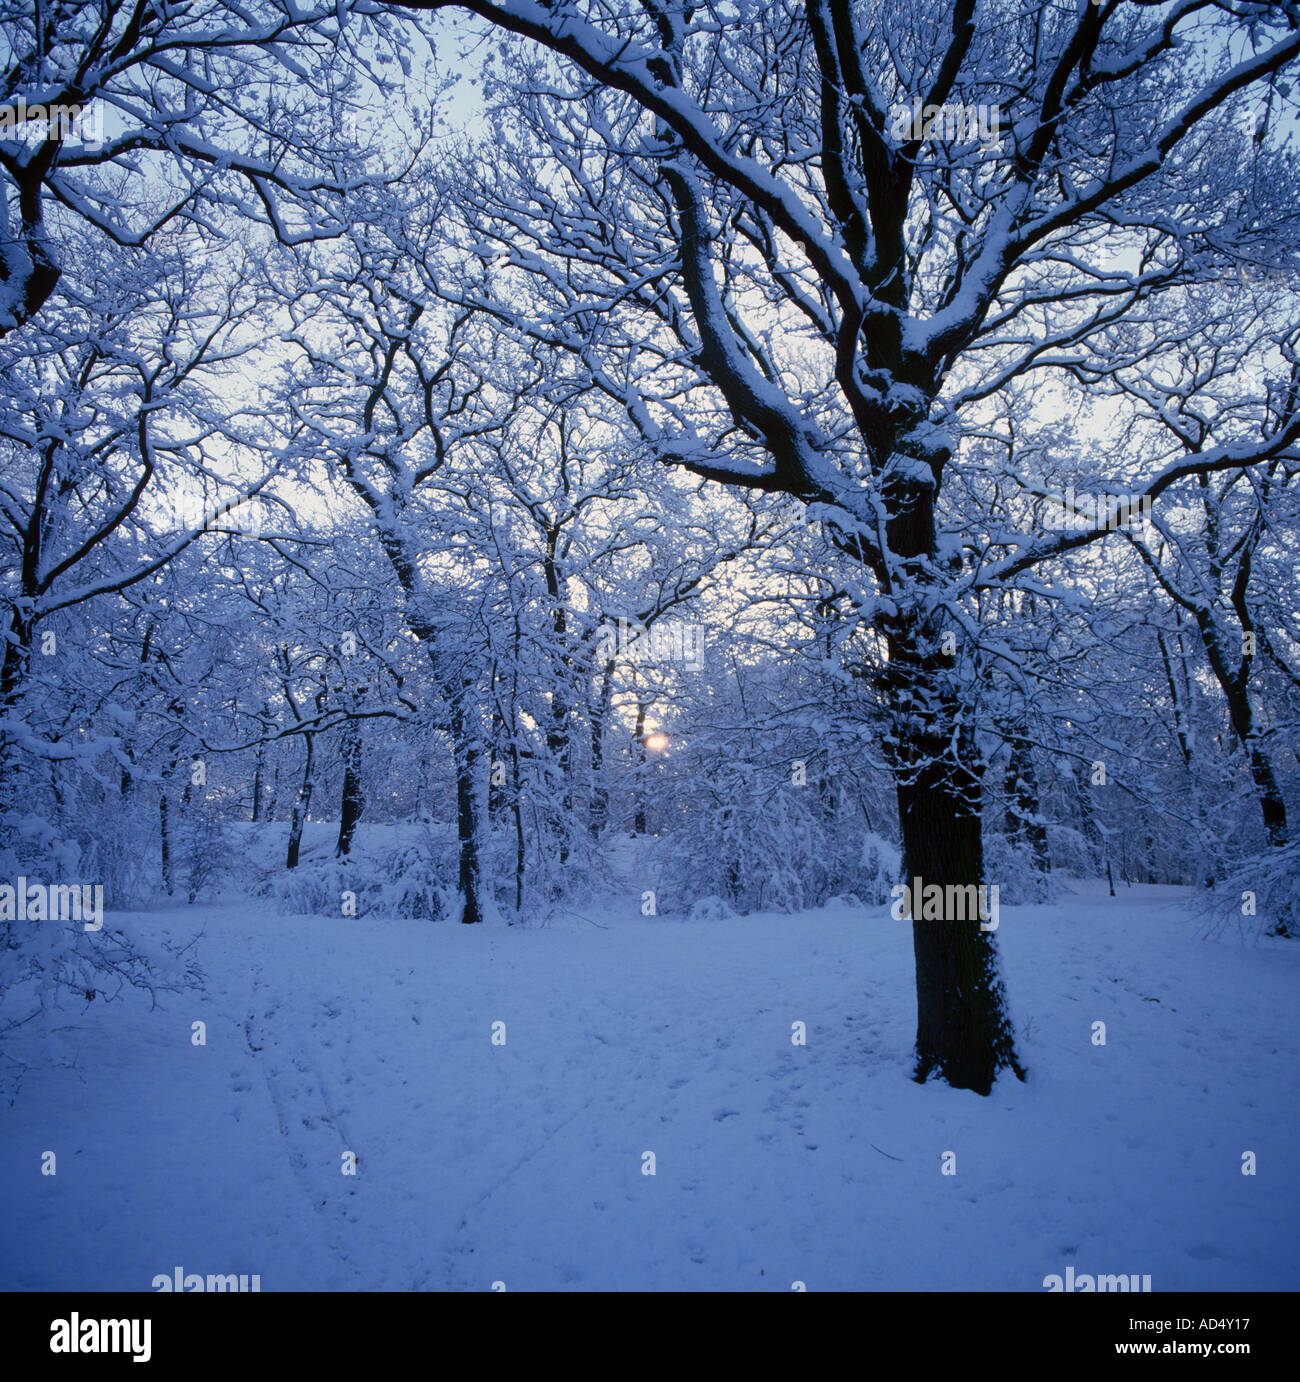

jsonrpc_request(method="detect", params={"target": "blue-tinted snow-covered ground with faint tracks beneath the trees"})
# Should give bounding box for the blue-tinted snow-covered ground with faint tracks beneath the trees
[0,862,1300,1291]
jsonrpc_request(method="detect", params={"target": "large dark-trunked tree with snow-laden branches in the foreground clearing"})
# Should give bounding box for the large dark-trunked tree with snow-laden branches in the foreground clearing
[386,0,1300,1092]
